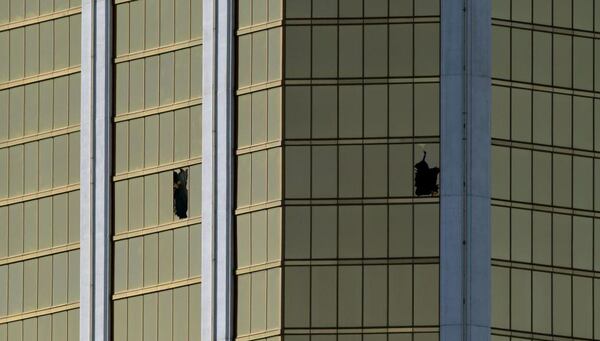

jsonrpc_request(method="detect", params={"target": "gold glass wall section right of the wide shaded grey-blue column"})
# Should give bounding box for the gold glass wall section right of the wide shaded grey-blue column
[492,0,600,341]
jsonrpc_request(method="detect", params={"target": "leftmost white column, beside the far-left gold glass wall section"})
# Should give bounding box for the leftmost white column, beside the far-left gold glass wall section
[79,0,112,341]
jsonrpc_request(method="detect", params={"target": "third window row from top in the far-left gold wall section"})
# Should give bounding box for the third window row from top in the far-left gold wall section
[0,73,81,142]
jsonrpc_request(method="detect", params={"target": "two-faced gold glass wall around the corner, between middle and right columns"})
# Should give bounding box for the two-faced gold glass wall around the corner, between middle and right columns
[236,0,440,341]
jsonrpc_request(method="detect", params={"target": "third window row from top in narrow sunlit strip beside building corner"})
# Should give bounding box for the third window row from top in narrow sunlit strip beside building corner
[237,88,282,148]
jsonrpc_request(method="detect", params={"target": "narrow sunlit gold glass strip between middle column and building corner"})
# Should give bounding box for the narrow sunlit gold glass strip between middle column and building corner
[235,0,284,340]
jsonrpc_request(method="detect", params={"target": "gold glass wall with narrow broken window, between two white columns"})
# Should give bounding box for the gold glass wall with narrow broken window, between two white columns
[112,0,202,341]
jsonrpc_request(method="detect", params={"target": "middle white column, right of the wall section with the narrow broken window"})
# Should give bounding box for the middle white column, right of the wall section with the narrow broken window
[202,0,235,341]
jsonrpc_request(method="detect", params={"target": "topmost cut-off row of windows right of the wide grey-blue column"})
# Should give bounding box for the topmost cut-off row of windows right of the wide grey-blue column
[492,0,600,31]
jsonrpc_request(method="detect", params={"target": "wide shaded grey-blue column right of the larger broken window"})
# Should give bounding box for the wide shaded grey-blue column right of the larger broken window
[440,0,491,341]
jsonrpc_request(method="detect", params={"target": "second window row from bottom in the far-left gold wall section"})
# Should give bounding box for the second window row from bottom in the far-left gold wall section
[0,250,79,314]
